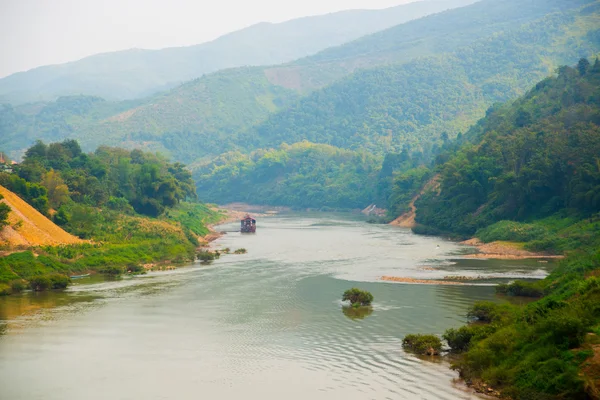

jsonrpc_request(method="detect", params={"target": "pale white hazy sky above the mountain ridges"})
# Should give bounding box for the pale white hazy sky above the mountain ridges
[0,0,412,77]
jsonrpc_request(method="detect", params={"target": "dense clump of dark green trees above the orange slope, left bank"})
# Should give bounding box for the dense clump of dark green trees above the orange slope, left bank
[0,140,196,216]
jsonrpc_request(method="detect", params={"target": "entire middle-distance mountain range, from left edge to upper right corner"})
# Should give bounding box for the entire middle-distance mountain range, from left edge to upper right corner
[0,0,600,166]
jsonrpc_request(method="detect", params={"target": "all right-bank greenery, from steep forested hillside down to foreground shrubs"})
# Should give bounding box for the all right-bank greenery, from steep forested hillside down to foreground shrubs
[400,59,600,400]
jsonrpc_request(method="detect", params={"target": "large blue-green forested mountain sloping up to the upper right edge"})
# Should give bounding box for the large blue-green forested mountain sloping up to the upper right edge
[252,1,600,152]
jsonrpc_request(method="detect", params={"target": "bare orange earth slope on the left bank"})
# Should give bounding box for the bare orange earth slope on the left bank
[0,186,83,247]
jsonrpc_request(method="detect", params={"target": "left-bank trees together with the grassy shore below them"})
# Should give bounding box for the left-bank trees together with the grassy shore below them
[0,141,222,292]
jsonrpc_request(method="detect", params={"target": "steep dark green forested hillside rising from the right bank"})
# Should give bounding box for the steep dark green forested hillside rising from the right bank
[416,59,600,239]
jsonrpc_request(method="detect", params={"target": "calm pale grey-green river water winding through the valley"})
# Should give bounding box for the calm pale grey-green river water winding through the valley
[0,214,550,400]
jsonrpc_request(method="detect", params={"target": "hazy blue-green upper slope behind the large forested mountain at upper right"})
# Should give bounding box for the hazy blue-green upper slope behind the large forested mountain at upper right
[265,0,589,91]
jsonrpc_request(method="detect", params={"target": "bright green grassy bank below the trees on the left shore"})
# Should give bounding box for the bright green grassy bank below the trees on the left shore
[0,204,222,294]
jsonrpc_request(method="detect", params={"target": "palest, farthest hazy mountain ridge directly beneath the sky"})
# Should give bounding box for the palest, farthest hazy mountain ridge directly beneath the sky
[0,0,476,104]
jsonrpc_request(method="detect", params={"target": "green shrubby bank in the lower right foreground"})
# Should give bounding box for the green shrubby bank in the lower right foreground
[436,250,600,400]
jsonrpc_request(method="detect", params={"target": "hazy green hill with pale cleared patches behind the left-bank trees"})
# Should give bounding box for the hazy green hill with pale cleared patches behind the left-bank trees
[0,67,298,162]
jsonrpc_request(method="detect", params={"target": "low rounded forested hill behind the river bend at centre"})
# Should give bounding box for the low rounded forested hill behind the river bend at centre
[194,142,378,208]
